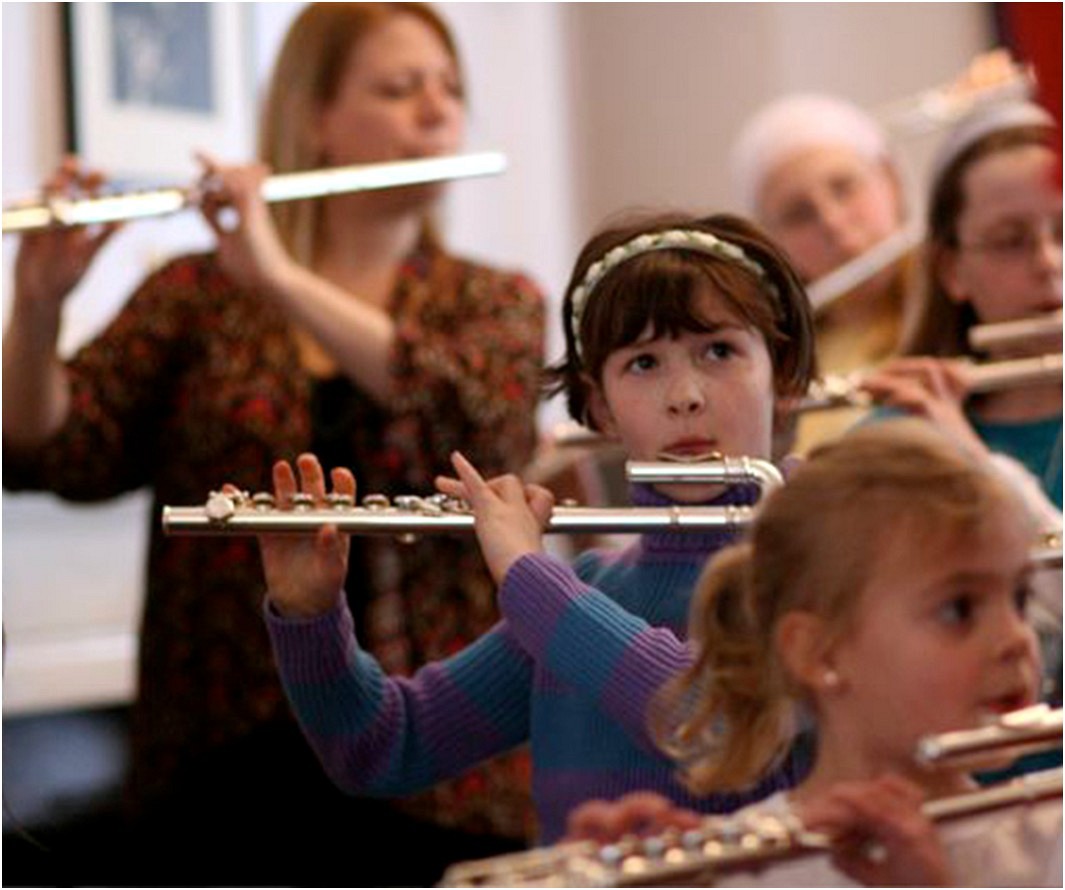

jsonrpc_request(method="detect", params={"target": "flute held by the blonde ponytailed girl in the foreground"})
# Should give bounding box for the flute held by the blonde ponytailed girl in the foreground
[440,708,1062,887]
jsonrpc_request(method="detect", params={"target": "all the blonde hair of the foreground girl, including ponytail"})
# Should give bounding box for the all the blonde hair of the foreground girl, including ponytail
[652,418,1023,793]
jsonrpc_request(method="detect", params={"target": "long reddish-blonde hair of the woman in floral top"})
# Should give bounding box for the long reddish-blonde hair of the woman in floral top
[259,3,461,264]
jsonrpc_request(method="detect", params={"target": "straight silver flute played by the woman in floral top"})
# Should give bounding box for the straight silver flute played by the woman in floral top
[3,151,507,234]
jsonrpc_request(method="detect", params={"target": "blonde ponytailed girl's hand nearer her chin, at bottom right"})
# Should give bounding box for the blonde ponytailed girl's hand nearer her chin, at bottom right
[799,776,952,887]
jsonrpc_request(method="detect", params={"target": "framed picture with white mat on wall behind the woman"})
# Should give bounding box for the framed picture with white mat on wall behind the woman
[64,3,255,184]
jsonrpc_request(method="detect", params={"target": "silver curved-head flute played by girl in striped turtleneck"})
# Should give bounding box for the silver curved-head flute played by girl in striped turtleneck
[162,457,783,540]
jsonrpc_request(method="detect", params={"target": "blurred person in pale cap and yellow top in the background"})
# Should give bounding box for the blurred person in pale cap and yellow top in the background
[732,94,914,451]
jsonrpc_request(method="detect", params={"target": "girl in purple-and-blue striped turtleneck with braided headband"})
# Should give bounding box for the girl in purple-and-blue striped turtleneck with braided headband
[260,216,814,841]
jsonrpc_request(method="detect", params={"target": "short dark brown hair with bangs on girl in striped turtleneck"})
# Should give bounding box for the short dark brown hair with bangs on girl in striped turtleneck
[545,213,817,428]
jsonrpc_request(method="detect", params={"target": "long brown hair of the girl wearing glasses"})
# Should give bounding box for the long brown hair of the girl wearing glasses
[899,125,1054,357]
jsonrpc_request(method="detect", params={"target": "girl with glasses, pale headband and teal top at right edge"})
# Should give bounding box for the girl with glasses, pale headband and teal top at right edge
[864,102,1062,515]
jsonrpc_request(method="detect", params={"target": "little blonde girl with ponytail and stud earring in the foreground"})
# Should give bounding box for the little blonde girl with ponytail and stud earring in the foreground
[570,419,1062,887]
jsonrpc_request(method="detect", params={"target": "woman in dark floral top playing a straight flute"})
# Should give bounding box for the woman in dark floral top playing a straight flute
[3,3,543,885]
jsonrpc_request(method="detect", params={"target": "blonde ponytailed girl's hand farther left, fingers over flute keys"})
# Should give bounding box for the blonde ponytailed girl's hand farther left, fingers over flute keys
[562,791,702,843]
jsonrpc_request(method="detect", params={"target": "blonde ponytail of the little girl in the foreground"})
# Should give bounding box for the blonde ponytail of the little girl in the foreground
[651,542,792,793]
